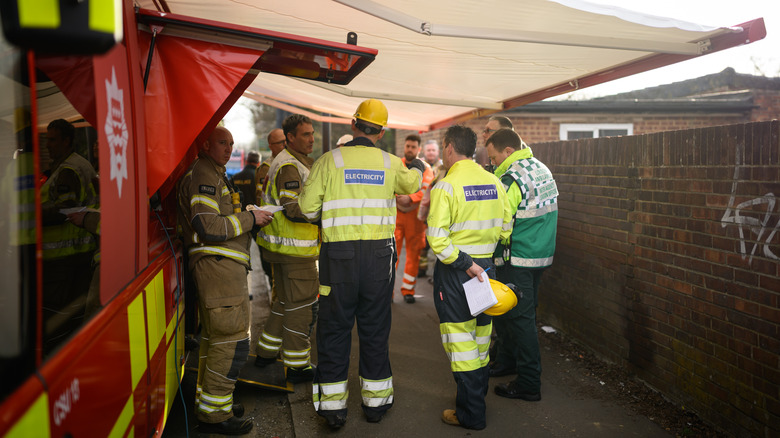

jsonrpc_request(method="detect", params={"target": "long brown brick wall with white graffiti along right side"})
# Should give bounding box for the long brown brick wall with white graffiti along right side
[532,120,780,437]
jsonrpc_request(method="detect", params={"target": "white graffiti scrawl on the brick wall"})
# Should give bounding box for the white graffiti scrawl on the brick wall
[720,148,780,264]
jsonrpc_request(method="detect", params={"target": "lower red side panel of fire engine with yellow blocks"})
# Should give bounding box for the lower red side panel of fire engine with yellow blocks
[0,251,184,437]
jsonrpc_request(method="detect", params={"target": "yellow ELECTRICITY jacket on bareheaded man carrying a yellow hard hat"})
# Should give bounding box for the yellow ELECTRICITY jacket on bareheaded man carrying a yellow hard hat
[426,160,514,269]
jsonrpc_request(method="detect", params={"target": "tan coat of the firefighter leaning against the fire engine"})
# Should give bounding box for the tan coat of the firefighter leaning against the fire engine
[178,153,255,268]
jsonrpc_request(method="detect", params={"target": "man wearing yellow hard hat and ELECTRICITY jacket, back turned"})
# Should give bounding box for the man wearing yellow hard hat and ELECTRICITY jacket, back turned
[298,99,422,429]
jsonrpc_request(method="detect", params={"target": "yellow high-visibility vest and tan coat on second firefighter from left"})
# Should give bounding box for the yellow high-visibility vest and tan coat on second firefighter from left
[257,149,320,258]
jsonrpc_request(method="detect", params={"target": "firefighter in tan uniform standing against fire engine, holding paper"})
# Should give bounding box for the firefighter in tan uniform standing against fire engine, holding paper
[178,127,272,435]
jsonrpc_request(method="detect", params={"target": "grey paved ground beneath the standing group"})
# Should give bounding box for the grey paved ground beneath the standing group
[164,248,670,438]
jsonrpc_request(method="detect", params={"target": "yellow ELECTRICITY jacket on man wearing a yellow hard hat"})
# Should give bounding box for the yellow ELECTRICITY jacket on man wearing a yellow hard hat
[298,137,422,242]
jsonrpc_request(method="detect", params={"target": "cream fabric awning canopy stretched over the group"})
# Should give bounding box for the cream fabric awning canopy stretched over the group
[137,0,766,131]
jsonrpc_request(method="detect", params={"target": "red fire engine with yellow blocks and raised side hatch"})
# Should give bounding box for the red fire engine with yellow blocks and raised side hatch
[0,0,377,437]
